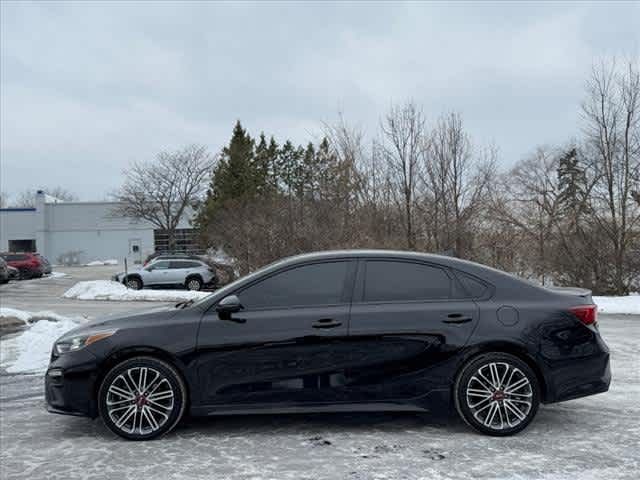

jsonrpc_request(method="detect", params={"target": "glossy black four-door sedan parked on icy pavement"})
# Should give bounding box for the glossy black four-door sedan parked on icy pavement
[46,251,611,440]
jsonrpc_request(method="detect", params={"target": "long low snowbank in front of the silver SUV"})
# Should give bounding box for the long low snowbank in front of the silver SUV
[62,280,209,302]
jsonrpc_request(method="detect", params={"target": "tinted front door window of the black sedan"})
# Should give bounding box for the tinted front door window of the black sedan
[239,262,348,308]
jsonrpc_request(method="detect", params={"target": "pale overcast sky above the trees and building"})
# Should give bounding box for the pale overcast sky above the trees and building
[0,1,640,200]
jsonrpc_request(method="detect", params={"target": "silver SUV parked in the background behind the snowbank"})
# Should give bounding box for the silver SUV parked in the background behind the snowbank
[112,259,217,290]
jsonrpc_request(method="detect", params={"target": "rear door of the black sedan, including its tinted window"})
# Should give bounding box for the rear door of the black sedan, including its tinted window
[345,261,478,402]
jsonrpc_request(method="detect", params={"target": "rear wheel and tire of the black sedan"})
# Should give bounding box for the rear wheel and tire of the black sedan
[455,353,540,436]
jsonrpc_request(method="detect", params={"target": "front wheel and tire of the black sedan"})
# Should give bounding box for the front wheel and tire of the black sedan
[98,357,187,440]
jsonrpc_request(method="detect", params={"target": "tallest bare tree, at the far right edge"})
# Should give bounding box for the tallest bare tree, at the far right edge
[582,61,640,294]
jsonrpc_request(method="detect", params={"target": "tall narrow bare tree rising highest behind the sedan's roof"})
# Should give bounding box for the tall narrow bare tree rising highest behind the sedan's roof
[377,102,425,249]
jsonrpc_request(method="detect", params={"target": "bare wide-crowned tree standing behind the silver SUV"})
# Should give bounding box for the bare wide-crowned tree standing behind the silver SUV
[111,145,214,249]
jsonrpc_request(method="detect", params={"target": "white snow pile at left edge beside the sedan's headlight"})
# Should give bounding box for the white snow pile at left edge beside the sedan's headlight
[0,308,85,373]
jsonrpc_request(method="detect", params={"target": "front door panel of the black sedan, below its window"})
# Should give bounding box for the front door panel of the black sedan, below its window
[198,305,349,404]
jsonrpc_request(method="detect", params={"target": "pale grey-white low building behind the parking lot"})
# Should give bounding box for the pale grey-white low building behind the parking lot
[0,191,195,263]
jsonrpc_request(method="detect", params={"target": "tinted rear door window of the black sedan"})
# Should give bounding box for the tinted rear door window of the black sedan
[364,261,451,302]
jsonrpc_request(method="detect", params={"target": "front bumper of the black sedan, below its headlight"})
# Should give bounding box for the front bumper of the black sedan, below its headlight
[44,349,98,418]
